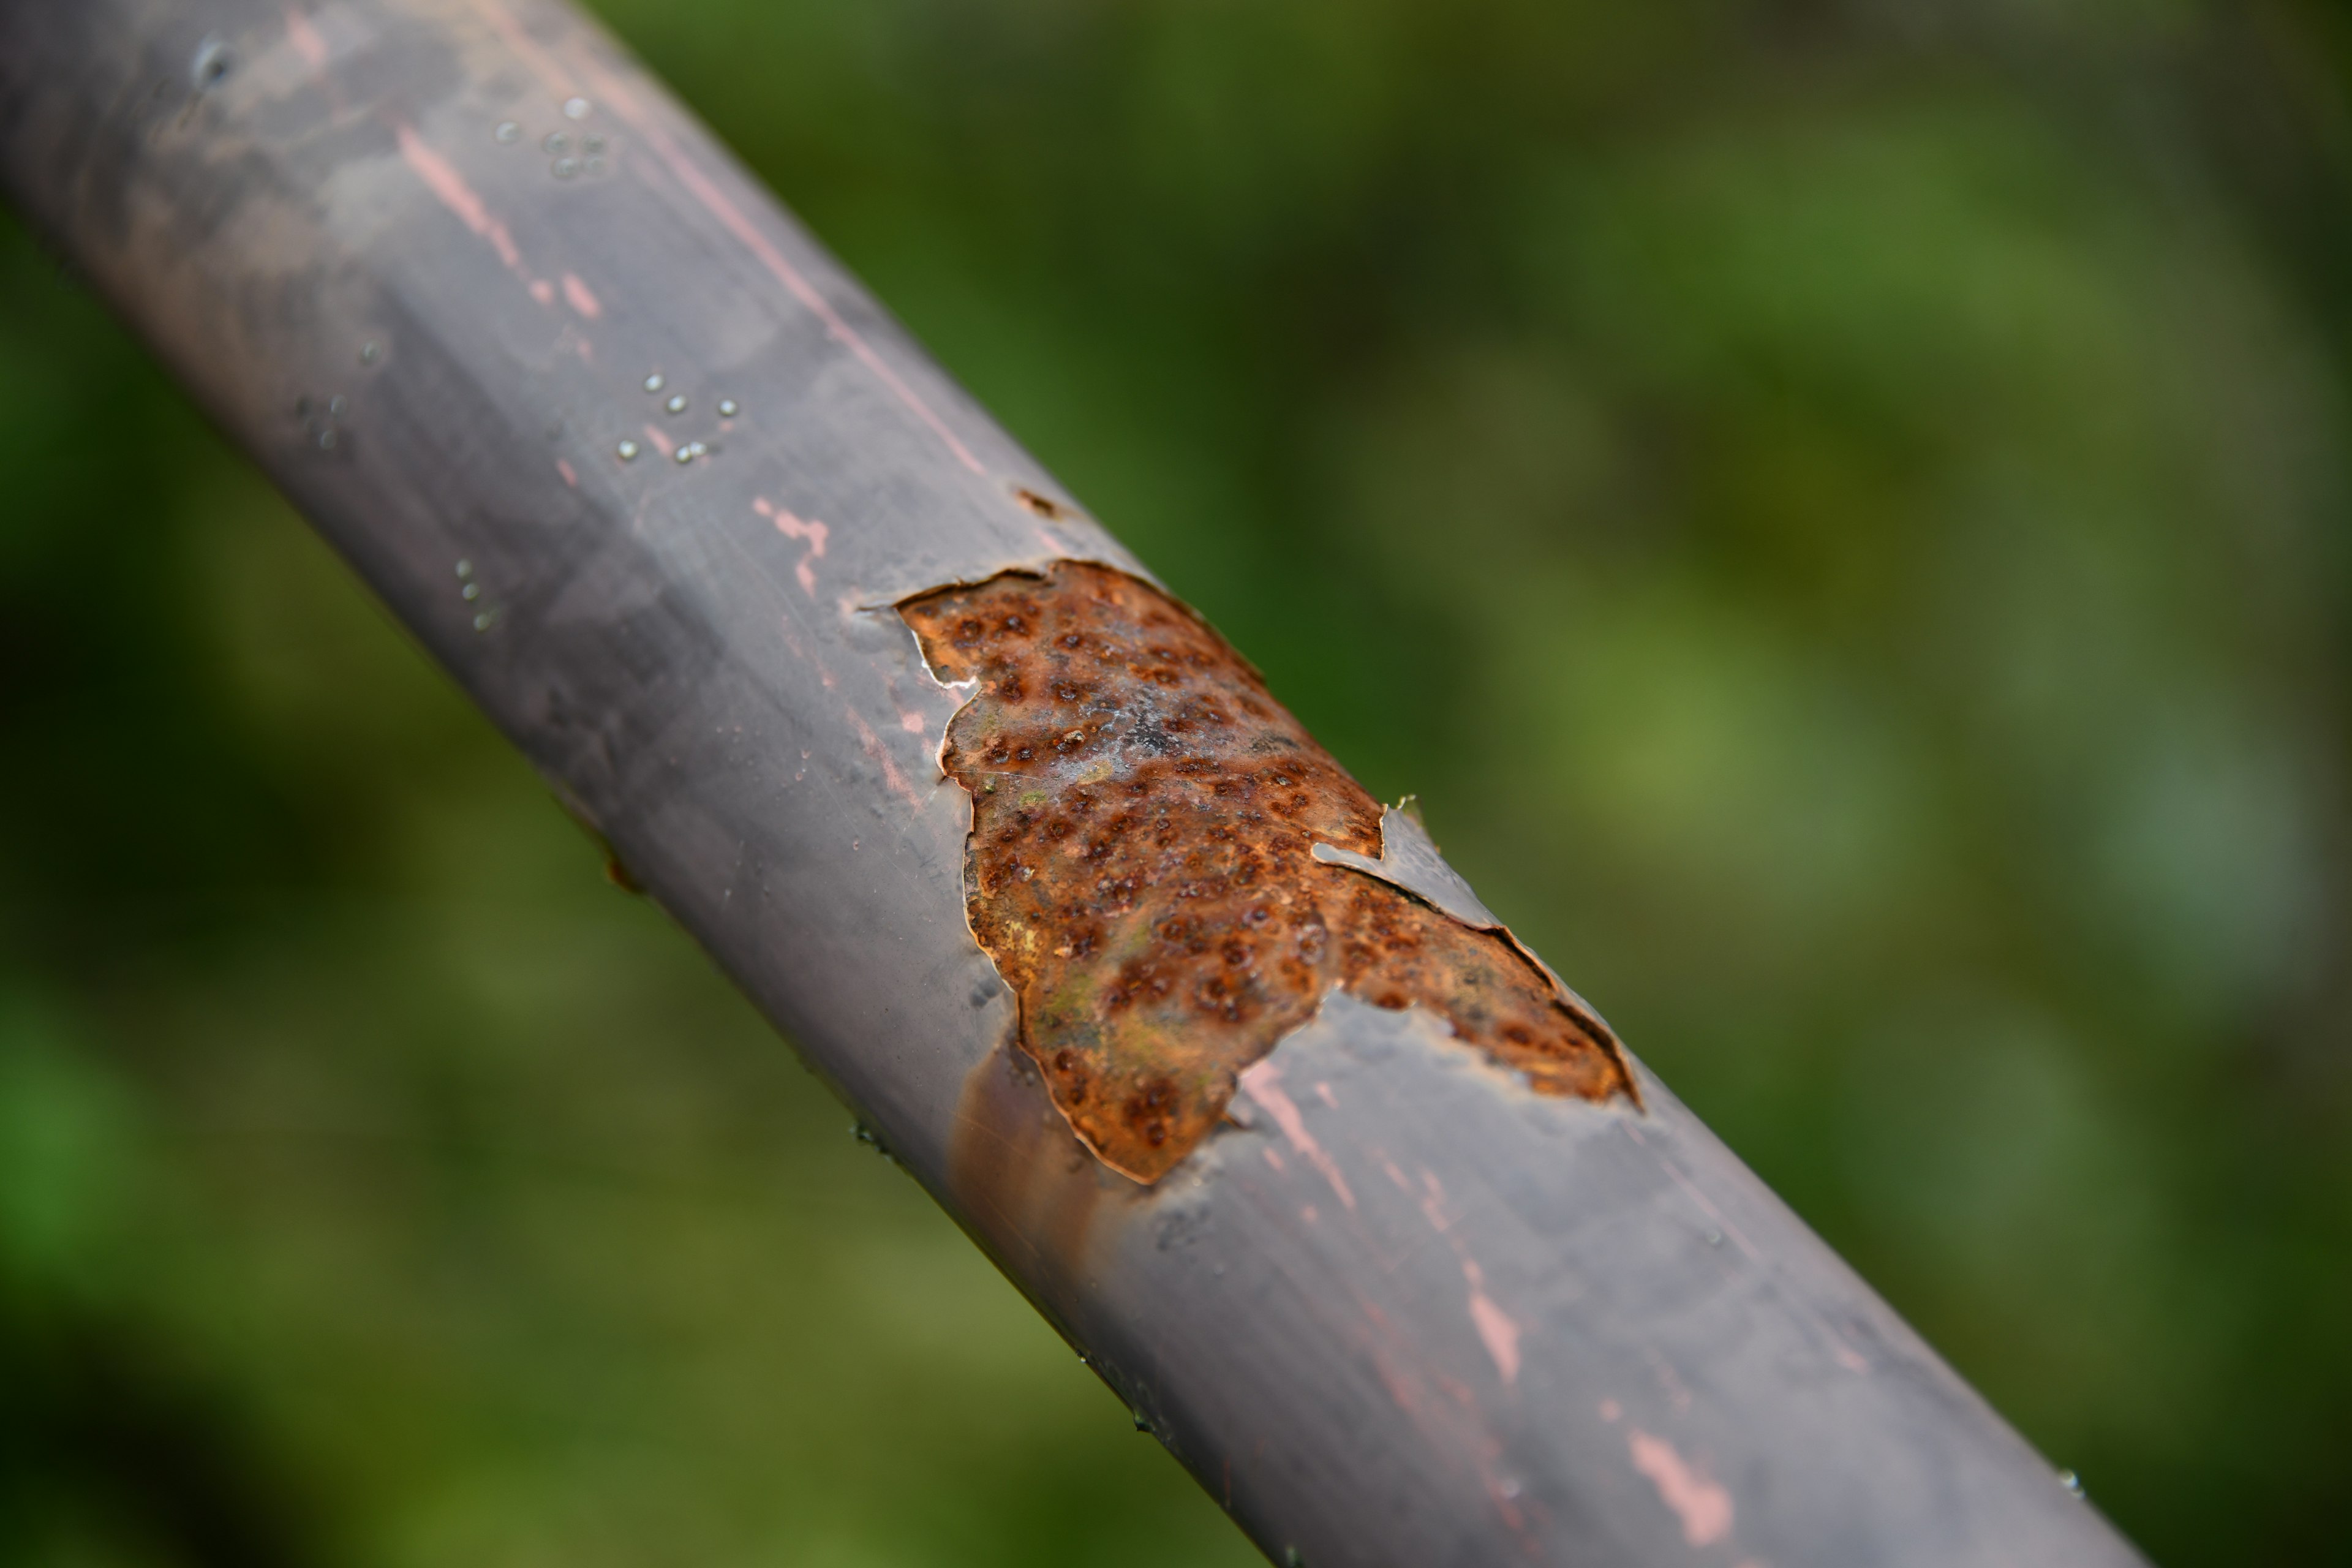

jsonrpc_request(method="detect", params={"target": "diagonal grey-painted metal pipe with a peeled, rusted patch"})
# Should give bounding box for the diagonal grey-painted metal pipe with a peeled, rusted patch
[0,0,2138,1568]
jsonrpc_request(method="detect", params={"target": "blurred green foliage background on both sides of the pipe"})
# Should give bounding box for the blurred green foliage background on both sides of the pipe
[0,0,2352,1568]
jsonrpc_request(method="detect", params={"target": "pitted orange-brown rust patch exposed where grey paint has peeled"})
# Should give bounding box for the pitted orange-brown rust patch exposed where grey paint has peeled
[901,562,1632,1183]
